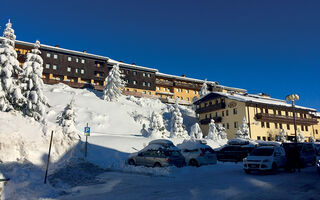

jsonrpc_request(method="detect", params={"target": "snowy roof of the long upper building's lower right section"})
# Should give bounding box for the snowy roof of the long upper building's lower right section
[156,72,247,92]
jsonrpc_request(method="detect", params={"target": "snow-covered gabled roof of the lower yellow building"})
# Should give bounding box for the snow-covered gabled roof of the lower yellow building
[194,92,317,112]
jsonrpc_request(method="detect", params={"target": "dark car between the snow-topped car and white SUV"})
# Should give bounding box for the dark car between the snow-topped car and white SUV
[217,145,255,162]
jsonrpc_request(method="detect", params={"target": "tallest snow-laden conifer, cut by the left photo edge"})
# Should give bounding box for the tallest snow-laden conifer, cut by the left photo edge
[0,20,22,111]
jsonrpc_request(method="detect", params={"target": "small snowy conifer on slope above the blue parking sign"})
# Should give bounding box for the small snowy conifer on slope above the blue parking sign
[57,98,78,137]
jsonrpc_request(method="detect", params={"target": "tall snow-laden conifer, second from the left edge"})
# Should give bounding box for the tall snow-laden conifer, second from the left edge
[18,40,48,120]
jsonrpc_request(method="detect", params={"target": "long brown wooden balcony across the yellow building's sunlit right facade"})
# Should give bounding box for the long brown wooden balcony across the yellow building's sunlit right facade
[256,113,318,126]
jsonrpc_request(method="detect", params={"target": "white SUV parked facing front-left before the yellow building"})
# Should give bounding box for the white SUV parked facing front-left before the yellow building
[243,146,286,173]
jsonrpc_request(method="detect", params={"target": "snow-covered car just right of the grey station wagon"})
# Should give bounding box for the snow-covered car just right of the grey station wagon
[178,141,217,167]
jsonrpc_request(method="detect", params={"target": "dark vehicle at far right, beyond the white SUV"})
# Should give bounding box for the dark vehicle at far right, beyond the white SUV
[282,143,316,167]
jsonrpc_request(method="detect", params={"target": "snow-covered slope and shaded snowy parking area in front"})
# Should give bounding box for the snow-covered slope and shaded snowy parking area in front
[0,84,320,199]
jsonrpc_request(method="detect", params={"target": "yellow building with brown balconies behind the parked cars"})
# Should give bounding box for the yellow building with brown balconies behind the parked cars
[194,92,320,141]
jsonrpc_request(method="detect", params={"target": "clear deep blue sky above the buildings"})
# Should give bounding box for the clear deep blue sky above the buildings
[0,0,320,110]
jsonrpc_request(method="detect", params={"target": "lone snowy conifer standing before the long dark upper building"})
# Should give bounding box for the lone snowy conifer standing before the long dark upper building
[102,64,125,101]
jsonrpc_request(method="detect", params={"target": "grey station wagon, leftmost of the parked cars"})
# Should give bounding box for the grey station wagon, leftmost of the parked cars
[128,140,185,167]
